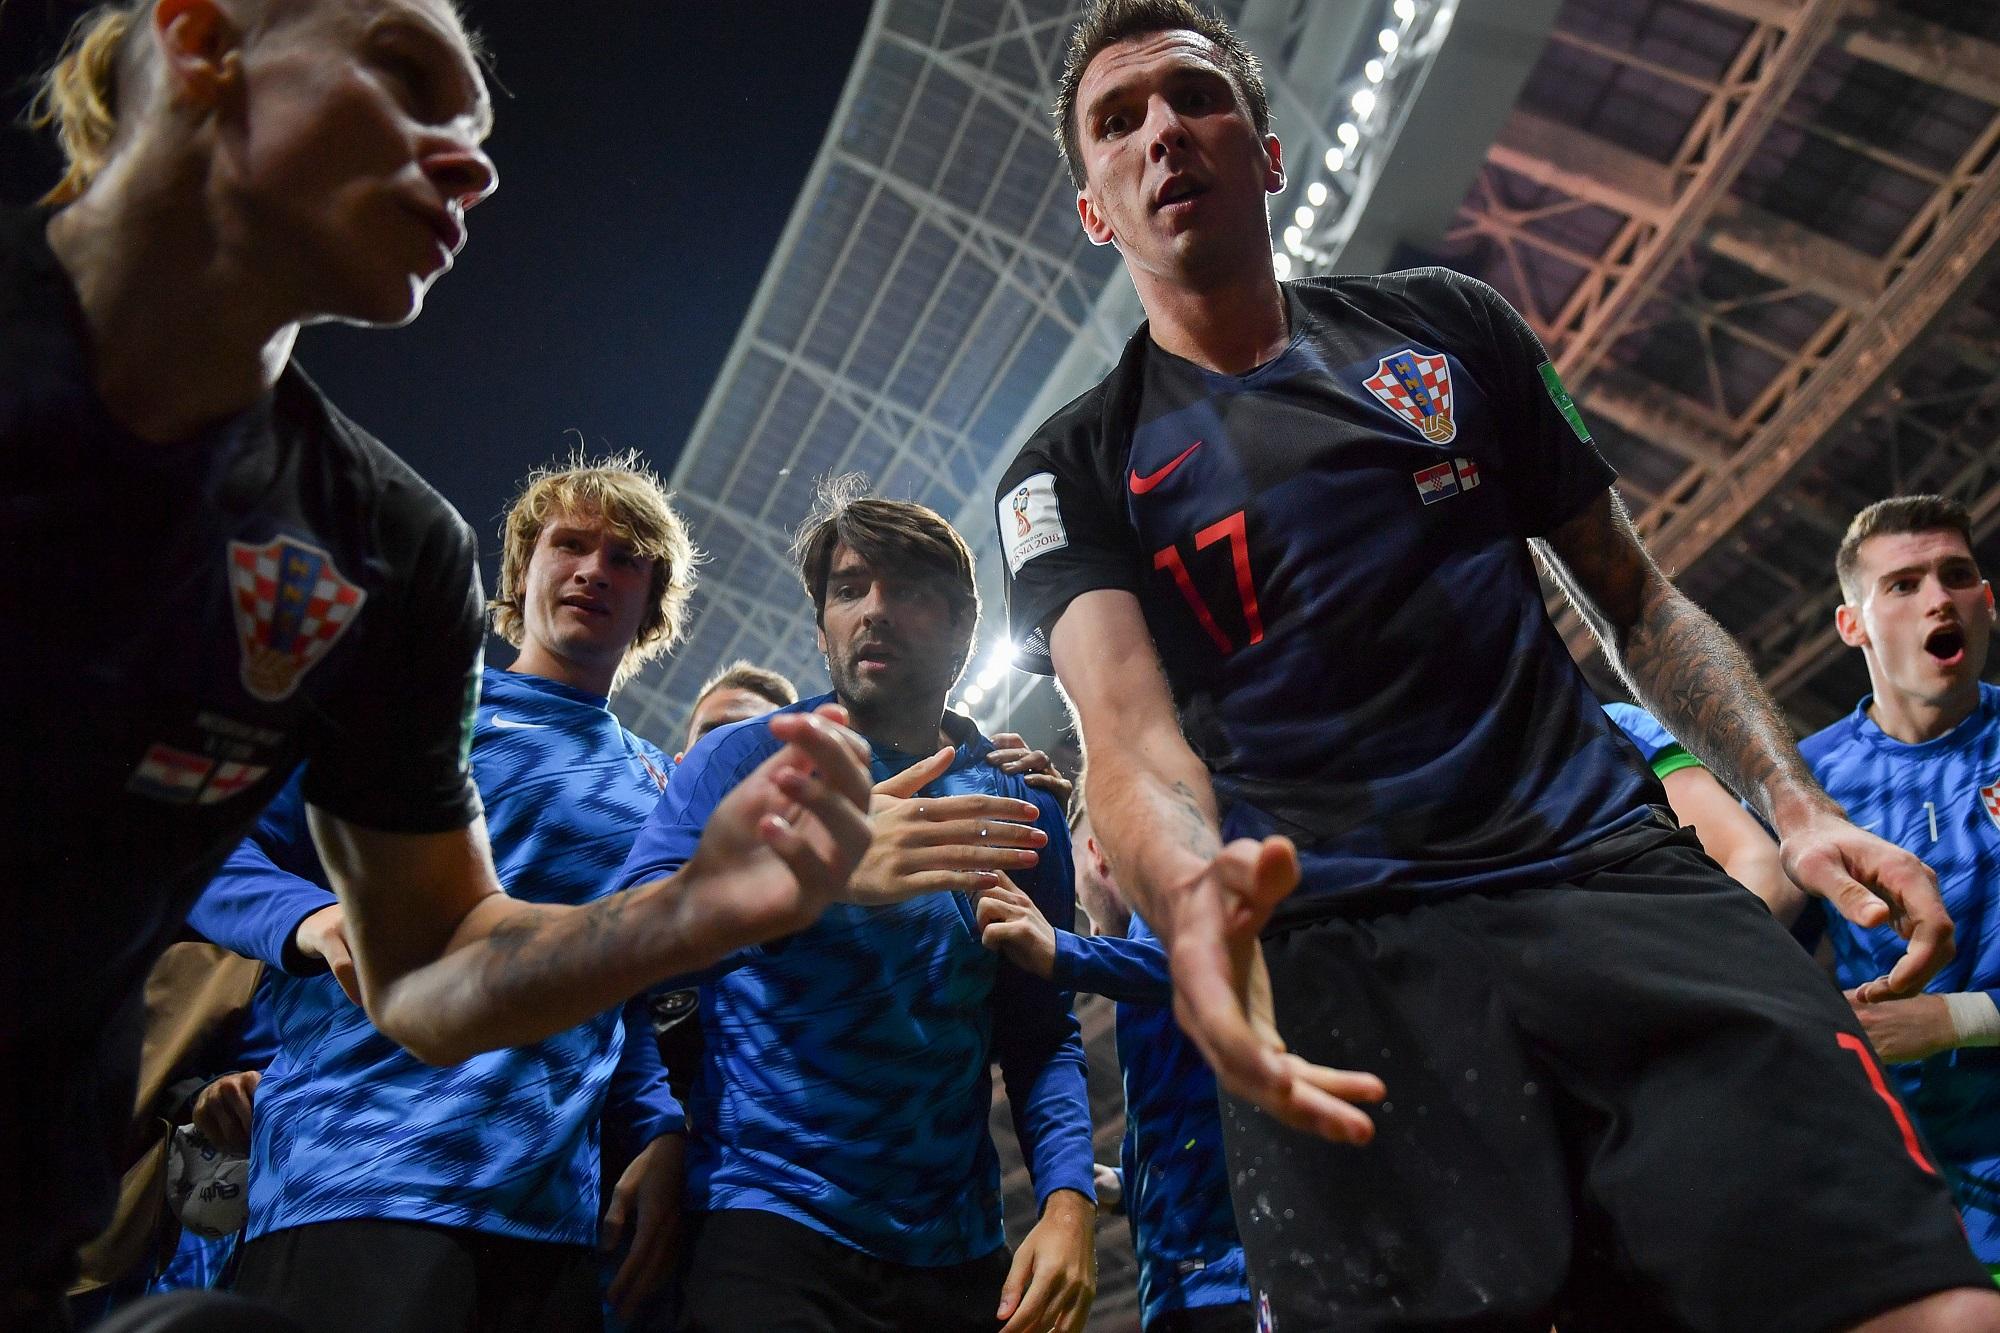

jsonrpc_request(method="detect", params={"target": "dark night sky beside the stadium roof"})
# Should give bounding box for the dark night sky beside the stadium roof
[0,0,868,592]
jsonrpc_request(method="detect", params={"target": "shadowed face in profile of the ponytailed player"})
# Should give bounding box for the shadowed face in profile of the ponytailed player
[220,0,496,324]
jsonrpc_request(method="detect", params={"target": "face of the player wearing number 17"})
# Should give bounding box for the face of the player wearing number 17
[1074,30,1284,282]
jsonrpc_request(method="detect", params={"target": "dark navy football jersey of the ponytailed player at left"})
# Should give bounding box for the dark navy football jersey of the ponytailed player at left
[0,210,486,1285]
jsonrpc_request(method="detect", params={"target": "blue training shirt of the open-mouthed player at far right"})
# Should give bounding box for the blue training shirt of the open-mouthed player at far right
[1798,685,2000,1263]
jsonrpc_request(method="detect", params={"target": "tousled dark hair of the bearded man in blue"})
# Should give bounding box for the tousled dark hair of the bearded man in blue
[792,472,980,640]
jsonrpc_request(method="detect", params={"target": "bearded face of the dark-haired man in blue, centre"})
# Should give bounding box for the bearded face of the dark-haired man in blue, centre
[820,546,972,713]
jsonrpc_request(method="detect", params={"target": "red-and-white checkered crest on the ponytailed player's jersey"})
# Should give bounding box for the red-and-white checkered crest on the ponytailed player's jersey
[230,536,368,703]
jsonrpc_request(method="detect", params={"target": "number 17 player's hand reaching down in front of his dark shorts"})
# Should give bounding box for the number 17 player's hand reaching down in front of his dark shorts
[1168,837,1386,1143]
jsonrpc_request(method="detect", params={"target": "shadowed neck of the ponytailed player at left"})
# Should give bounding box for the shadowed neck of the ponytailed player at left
[48,170,298,444]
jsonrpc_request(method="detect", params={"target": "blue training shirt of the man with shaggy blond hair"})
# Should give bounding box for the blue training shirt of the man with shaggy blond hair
[190,669,682,1245]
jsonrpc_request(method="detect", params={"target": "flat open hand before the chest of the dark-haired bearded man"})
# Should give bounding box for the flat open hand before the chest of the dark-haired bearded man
[842,749,1048,907]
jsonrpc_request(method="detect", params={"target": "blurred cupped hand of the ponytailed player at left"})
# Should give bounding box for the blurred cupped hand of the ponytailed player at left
[674,705,870,957]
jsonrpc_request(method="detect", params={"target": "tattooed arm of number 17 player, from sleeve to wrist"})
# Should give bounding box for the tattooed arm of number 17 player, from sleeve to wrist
[1548,482,1832,831]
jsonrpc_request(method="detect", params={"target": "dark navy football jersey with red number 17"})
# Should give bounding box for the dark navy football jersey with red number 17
[998,270,1670,893]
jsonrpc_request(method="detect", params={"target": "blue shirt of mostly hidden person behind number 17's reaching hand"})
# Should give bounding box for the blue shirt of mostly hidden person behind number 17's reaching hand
[1056,913,1250,1325]
